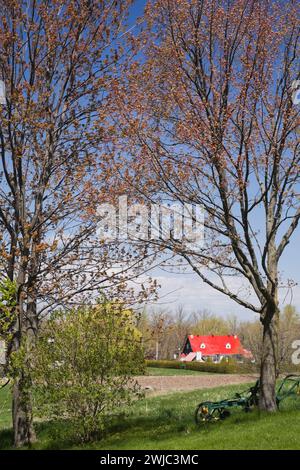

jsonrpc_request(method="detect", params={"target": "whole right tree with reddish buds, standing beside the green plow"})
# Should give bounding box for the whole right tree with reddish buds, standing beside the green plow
[110,0,300,411]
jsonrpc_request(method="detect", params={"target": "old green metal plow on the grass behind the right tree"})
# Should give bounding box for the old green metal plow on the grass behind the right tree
[195,374,300,424]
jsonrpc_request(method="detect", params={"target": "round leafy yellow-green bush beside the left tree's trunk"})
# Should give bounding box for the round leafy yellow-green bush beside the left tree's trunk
[32,303,144,441]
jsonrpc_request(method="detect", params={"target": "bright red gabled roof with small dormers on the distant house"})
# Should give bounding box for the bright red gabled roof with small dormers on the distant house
[187,335,251,356]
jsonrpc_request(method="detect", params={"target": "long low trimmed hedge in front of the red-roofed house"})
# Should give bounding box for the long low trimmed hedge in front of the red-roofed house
[146,360,239,374]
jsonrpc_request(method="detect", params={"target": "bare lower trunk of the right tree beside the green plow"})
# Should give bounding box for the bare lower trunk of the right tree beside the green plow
[259,306,279,411]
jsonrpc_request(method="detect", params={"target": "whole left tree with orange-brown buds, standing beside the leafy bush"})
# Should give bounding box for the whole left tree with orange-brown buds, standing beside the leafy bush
[0,0,155,446]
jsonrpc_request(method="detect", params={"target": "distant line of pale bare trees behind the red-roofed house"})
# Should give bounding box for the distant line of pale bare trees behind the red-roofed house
[138,305,300,371]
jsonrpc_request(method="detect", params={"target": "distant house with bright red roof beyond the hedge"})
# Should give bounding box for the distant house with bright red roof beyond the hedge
[180,335,253,362]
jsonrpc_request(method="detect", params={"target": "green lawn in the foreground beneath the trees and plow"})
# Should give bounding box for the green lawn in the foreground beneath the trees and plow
[0,385,300,450]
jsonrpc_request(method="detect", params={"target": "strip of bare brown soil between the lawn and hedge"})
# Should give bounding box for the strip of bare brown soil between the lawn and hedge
[137,374,257,395]
